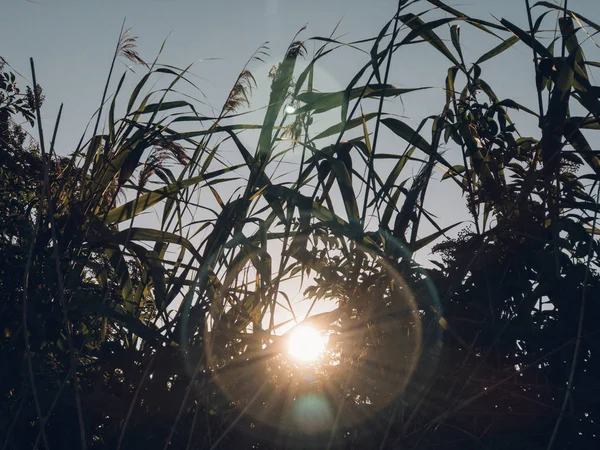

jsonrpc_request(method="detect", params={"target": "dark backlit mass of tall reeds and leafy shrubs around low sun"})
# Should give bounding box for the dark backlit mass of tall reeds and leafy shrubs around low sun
[0,0,600,449]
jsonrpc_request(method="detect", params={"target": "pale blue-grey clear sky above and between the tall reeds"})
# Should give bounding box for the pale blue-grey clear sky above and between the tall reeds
[0,0,600,322]
